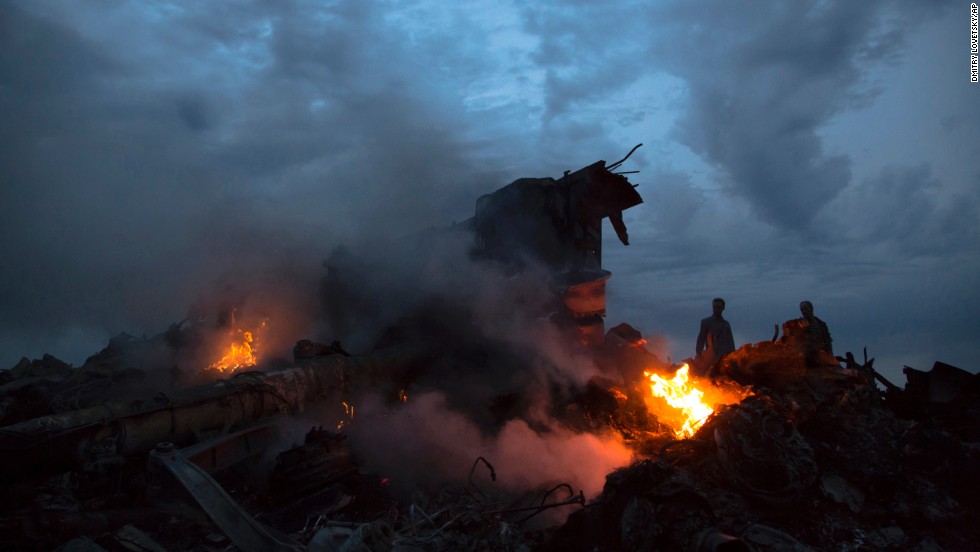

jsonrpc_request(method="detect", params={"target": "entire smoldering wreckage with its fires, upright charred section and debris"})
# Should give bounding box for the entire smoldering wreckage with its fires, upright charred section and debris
[0,146,980,552]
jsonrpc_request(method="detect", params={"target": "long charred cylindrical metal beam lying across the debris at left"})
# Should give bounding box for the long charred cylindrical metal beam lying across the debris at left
[0,342,427,479]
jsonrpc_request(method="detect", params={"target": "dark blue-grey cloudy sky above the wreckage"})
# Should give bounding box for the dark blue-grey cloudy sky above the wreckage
[0,0,980,383]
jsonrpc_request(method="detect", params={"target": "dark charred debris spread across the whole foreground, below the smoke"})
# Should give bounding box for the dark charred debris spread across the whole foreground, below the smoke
[0,316,980,552]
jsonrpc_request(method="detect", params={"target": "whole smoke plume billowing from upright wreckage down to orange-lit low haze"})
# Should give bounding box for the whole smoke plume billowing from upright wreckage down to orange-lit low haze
[325,222,630,506]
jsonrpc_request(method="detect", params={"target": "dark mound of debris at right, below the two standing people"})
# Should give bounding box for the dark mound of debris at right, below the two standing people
[543,354,980,552]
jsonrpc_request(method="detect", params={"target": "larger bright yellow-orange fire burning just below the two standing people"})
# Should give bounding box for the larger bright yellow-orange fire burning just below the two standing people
[643,364,750,439]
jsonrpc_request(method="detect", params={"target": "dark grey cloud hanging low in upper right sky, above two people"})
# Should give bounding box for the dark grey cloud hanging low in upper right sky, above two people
[651,2,948,233]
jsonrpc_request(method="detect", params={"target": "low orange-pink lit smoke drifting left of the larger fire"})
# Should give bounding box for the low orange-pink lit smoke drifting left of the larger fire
[351,391,631,497]
